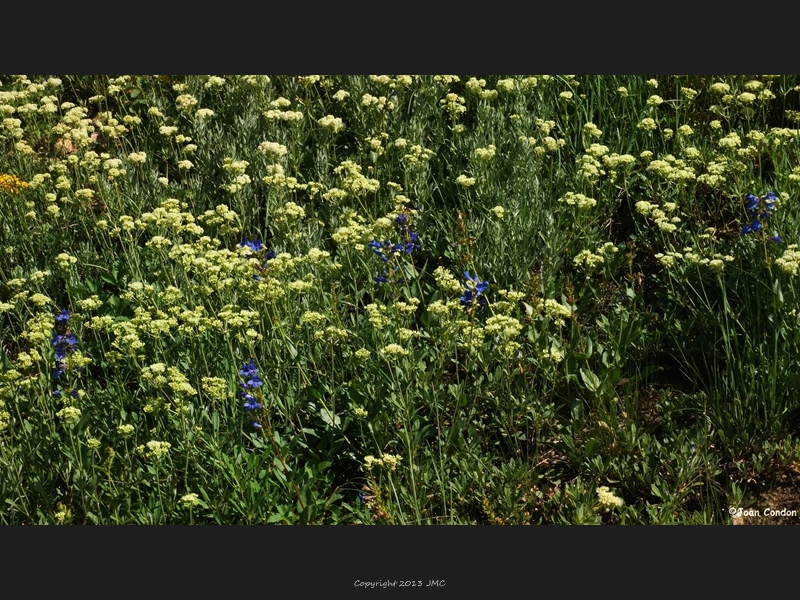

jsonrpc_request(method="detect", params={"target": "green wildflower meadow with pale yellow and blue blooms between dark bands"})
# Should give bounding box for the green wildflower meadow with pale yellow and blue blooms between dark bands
[0,75,800,525]
